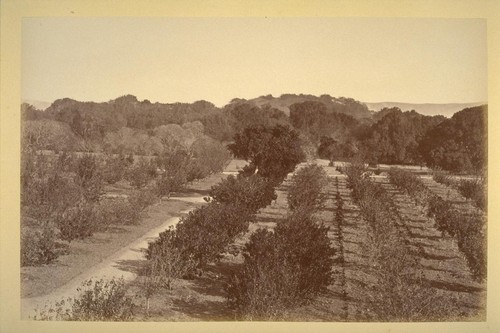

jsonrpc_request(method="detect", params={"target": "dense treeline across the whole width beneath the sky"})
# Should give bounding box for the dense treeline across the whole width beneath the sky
[22,95,487,173]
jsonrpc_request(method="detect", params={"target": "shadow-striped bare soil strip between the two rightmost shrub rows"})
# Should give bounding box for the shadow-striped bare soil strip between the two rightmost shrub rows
[375,178,486,321]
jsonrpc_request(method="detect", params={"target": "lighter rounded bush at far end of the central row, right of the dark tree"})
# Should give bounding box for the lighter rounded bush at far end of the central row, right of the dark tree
[288,164,328,212]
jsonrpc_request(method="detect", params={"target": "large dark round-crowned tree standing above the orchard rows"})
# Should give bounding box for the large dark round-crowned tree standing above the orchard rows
[228,125,305,183]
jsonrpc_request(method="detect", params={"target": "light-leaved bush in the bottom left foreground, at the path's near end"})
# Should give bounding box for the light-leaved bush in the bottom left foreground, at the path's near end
[34,278,134,321]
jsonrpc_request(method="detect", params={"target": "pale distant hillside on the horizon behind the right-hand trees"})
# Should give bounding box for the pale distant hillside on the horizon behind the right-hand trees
[365,102,486,118]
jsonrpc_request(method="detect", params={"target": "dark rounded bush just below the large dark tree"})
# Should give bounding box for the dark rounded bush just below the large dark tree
[210,175,277,213]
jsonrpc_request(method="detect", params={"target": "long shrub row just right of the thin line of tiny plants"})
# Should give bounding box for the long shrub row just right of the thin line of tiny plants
[346,172,458,321]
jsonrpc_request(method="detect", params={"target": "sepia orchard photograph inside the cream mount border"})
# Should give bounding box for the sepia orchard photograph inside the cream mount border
[2,0,495,332]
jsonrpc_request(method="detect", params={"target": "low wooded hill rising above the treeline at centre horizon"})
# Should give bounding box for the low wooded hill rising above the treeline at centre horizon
[231,94,372,119]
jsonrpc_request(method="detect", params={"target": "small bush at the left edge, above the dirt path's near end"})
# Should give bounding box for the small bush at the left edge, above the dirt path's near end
[21,225,58,266]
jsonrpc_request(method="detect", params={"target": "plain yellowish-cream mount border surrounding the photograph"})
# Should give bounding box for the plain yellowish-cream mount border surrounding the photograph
[0,0,500,333]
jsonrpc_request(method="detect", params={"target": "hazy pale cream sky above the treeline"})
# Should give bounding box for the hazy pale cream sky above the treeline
[22,18,487,106]
